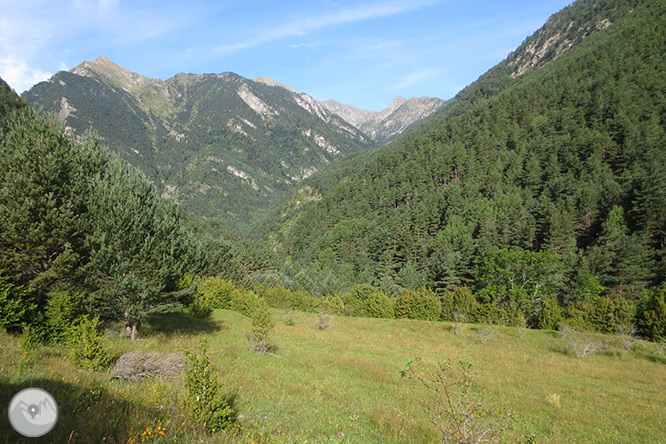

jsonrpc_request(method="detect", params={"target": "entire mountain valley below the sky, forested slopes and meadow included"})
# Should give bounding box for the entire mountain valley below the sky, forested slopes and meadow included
[0,0,666,444]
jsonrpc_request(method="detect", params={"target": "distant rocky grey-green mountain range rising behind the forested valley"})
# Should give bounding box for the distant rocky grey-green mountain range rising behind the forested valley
[23,57,445,225]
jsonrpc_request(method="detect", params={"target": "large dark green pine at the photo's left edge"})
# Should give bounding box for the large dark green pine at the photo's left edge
[0,110,106,298]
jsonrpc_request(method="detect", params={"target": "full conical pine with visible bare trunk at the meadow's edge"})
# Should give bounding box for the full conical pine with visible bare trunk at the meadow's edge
[86,161,203,340]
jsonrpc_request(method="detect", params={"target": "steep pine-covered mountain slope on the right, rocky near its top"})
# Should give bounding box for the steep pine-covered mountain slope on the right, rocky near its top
[272,1,666,296]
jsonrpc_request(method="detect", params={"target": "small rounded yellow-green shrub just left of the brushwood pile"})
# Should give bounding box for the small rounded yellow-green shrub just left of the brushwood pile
[67,315,111,370]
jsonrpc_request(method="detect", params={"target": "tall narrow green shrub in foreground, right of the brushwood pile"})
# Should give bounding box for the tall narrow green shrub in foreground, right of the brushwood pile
[184,339,237,432]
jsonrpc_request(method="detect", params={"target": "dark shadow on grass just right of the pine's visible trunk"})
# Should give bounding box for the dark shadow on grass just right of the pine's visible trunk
[139,312,227,338]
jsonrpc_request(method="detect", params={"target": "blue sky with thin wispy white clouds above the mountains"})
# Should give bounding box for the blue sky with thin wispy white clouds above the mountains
[0,0,571,110]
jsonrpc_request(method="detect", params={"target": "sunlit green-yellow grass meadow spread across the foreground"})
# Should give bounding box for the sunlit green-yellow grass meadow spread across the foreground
[0,310,666,444]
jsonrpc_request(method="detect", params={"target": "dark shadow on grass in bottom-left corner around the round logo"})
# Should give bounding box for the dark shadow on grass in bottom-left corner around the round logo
[0,376,170,444]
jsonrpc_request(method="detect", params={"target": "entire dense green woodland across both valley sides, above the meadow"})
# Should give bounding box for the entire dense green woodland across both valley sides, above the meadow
[0,0,666,350]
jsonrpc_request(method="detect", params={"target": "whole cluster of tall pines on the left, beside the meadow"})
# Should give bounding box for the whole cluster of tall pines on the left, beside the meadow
[0,88,208,342]
